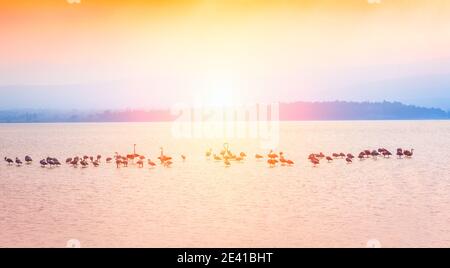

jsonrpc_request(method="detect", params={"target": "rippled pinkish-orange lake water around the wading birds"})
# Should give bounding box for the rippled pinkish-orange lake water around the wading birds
[0,121,450,247]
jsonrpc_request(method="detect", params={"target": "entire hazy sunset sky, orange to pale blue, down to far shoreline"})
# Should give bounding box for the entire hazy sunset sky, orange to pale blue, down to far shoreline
[0,0,450,109]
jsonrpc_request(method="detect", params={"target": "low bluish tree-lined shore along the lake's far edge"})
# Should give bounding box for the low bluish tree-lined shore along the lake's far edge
[0,101,450,123]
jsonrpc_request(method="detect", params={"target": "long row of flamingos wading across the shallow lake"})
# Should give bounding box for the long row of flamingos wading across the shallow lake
[4,143,414,168]
